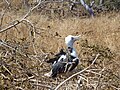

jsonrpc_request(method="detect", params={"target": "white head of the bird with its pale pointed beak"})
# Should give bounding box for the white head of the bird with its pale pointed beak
[65,35,80,48]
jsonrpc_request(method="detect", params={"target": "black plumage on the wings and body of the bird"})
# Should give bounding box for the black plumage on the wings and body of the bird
[47,48,79,78]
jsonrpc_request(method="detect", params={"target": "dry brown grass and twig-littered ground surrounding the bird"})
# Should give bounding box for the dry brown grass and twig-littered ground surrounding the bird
[0,0,120,90]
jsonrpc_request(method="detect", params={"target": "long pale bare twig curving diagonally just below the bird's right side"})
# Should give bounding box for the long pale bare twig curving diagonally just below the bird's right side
[54,53,100,90]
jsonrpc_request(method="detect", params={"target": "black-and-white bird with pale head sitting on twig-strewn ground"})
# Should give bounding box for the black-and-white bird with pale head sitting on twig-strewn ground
[45,35,80,78]
